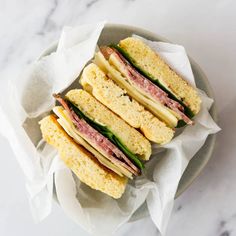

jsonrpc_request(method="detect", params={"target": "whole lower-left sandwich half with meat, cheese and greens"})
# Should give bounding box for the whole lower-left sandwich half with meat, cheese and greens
[40,89,151,198]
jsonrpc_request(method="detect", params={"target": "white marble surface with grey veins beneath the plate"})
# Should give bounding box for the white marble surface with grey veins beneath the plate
[0,0,236,236]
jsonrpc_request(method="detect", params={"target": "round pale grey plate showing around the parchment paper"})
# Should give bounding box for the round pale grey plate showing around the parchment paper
[40,24,217,221]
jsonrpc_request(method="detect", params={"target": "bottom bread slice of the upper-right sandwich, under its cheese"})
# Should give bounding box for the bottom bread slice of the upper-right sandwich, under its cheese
[80,63,174,144]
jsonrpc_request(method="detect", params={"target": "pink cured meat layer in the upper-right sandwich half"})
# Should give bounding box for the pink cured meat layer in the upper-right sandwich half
[100,47,193,124]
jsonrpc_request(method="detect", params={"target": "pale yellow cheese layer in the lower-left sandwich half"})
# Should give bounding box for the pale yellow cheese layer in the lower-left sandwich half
[53,106,133,179]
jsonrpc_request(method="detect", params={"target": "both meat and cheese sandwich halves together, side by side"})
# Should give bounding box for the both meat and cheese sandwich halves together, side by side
[40,37,201,199]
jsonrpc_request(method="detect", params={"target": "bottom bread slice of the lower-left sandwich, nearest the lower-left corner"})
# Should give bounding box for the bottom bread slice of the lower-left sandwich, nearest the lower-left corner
[40,115,127,199]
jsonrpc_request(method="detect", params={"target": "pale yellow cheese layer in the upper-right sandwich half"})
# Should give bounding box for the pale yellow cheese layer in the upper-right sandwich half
[94,52,178,128]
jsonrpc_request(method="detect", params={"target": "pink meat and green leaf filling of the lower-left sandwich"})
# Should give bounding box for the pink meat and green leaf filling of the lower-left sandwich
[54,94,143,176]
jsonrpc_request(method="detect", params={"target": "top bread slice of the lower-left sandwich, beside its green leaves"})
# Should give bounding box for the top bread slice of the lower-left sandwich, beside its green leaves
[66,89,151,160]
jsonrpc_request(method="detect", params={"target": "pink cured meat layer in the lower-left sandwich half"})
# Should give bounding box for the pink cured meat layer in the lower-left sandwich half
[53,94,140,176]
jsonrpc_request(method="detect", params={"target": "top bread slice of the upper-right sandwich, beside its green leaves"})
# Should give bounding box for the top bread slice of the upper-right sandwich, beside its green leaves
[119,37,201,114]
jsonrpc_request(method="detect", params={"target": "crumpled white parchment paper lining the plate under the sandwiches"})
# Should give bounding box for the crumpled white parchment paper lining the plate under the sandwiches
[0,22,220,235]
